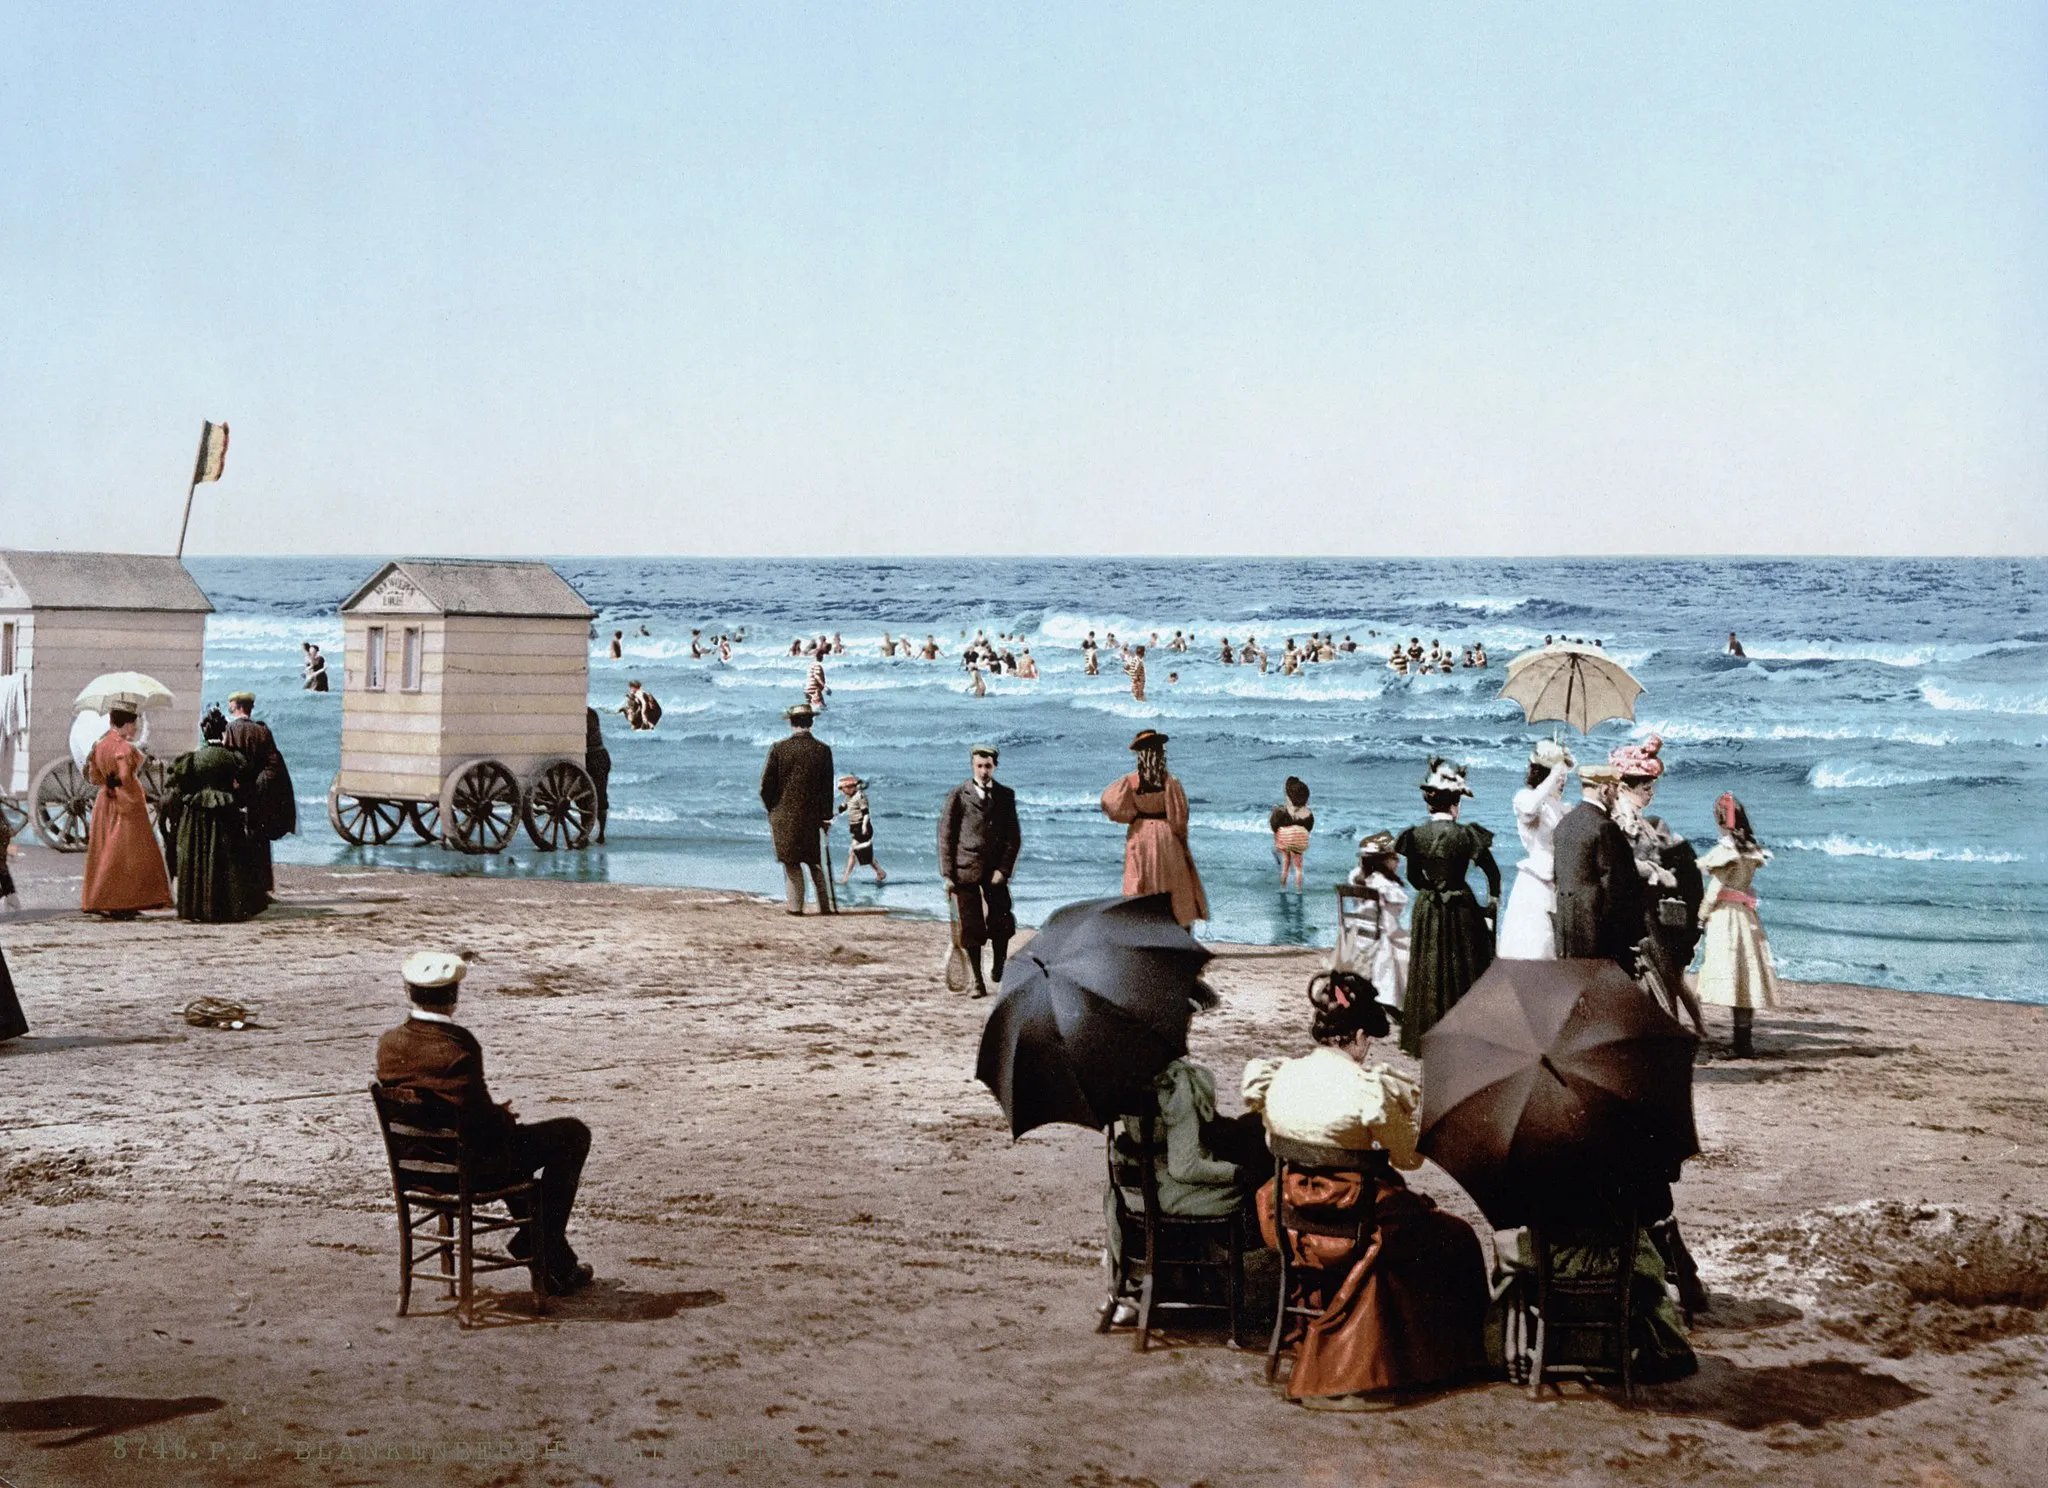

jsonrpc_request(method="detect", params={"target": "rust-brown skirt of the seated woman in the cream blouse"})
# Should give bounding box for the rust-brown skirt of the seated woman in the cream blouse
[1257,1173,1487,1398]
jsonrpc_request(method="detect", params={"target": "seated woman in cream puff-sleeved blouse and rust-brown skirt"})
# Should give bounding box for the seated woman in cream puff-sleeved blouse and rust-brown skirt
[1243,972,1487,1410]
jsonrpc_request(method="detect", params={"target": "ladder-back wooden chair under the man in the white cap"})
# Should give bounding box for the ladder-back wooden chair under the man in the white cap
[371,1081,547,1328]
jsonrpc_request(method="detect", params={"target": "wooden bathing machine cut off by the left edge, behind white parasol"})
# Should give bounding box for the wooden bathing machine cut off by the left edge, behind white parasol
[0,549,213,851]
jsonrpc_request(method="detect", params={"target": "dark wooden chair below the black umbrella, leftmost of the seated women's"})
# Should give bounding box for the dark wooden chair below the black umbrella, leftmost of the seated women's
[1096,1115,1245,1353]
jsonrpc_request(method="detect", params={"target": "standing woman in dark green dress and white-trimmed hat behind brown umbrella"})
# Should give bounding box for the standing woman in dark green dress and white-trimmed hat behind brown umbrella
[1395,755,1501,1056]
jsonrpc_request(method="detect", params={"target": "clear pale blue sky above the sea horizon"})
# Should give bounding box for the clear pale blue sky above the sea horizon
[0,0,2048,555]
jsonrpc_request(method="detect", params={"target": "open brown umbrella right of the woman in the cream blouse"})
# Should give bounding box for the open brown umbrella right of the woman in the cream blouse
[1421,960,1700,1228]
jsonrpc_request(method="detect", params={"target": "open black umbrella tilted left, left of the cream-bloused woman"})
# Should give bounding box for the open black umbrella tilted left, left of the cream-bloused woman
[975,894,1214,1136]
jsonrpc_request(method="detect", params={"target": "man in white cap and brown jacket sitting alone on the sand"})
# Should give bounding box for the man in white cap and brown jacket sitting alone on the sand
[377,950,592,1298]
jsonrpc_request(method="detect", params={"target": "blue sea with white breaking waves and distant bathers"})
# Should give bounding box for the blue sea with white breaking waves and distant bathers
[188,557,2048,1003]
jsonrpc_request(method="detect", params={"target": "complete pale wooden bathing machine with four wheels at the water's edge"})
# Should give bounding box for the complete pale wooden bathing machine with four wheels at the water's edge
[328,559,598,854]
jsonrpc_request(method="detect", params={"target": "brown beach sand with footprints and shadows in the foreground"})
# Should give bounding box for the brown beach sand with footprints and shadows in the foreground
[0,851,2048,1488]
